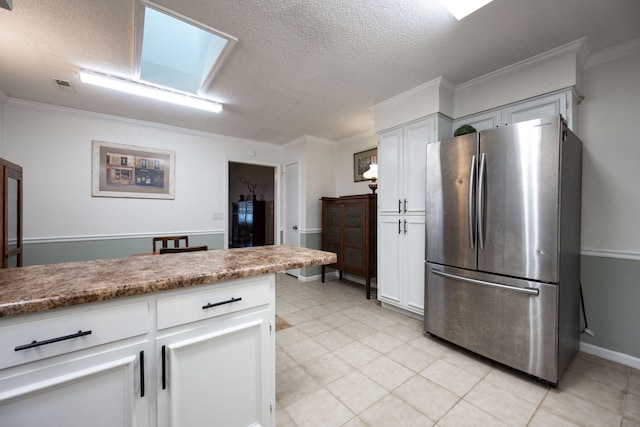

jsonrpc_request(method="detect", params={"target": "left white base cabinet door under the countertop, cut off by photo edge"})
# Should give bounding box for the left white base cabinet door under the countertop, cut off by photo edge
[0,343,149,427]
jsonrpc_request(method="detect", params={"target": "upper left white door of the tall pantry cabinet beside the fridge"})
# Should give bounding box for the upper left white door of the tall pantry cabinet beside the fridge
[378,129,402,214]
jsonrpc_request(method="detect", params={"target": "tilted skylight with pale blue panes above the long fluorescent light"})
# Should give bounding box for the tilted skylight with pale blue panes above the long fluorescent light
[139,2,237,94]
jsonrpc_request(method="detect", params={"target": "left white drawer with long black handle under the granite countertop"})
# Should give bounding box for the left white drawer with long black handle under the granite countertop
[0,301,149,369]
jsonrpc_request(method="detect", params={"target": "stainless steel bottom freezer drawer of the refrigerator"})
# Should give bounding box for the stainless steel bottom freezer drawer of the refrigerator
[424,263,559,383]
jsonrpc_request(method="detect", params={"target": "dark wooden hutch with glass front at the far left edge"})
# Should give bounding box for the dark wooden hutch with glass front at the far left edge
[0,159,22,268]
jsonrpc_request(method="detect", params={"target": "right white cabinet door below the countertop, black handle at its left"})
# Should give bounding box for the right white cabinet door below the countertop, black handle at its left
[157,310,275,427]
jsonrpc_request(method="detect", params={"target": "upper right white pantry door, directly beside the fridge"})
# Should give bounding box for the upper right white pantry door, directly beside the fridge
[402,119,435,214]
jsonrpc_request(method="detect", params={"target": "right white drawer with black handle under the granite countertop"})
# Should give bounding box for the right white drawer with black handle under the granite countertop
[158,279,270,330]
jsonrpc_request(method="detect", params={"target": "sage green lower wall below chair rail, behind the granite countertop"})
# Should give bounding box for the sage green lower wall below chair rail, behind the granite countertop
[23,234,224,266]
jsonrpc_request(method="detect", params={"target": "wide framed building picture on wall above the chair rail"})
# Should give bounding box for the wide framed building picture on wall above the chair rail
[91,141,176,199]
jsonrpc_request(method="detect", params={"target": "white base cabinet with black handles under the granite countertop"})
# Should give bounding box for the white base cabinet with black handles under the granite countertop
[0,274,275,427]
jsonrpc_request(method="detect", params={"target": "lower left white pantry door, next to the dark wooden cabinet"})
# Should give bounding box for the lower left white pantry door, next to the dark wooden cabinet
[378,216,404,305]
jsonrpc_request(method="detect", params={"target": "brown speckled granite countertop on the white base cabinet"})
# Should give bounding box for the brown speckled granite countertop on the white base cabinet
[0,245,337,317]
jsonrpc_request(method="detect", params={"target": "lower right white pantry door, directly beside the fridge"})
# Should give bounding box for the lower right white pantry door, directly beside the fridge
[404,216,425,314]
